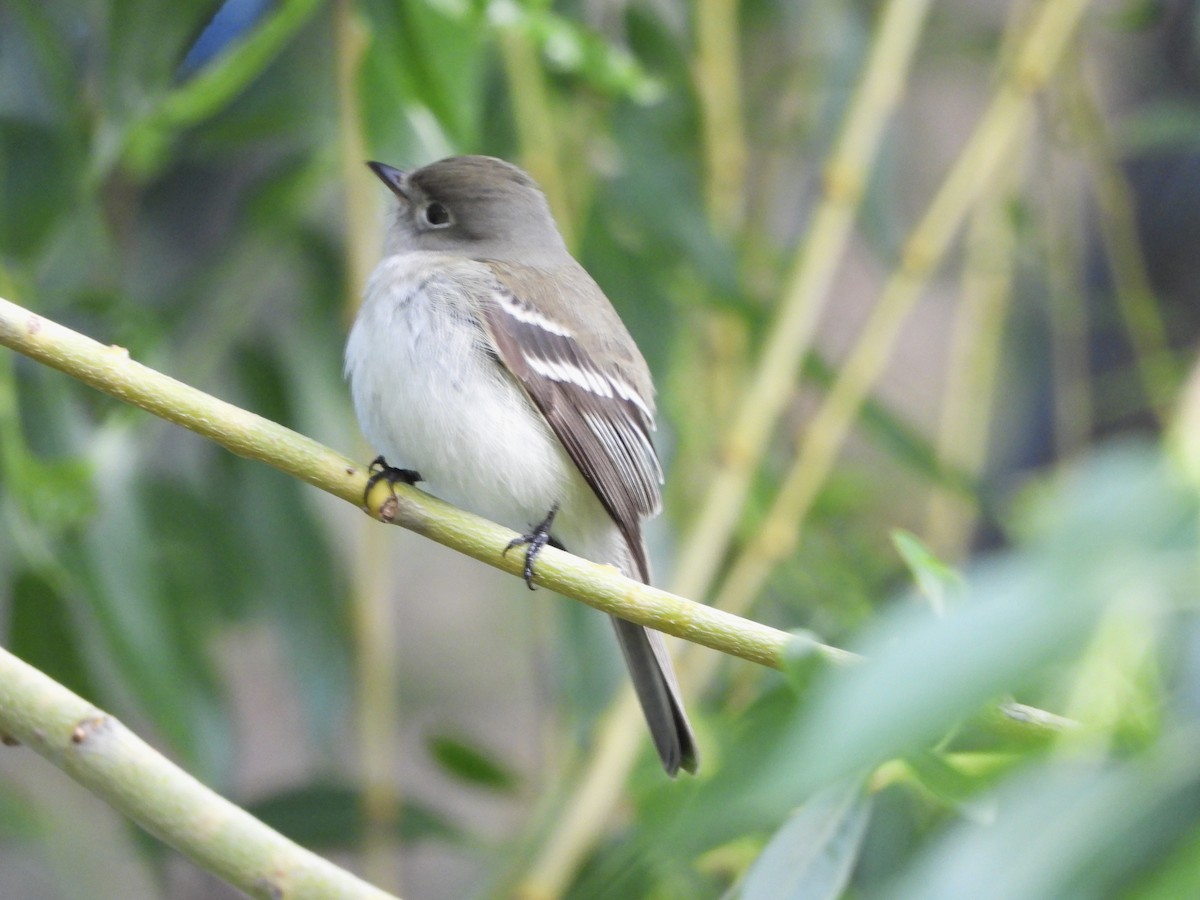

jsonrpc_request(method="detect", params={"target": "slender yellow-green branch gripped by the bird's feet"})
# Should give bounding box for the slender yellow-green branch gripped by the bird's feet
[0,298,830,667]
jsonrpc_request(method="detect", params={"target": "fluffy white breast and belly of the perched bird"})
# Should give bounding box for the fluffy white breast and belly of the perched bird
[346,252,598,542]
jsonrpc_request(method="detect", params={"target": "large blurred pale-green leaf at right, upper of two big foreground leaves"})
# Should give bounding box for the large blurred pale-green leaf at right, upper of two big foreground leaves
[754,446,1196,796]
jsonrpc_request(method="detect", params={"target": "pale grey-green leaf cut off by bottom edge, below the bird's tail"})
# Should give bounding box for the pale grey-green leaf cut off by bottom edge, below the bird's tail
[738,780,871,900]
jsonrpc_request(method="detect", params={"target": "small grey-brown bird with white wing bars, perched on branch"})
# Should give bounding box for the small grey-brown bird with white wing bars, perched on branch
[346,156,698,775]
